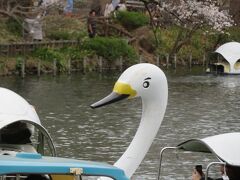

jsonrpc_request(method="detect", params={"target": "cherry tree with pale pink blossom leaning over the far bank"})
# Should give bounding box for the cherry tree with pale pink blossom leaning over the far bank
[141,0,234,55]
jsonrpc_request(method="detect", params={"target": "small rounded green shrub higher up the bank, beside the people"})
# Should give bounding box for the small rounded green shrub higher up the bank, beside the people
[116,11,149,30]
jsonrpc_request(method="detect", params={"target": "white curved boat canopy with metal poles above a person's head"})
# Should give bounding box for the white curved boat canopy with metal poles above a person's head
[158,133,240,180]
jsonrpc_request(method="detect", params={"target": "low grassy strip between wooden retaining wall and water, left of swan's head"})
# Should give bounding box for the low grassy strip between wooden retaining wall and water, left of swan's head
[0,37,138,75]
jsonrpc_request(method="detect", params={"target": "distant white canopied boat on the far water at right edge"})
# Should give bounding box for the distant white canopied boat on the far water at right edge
[207,42,240,74]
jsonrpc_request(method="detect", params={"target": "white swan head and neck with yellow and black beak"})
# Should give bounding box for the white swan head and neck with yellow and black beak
[91,63,168,178]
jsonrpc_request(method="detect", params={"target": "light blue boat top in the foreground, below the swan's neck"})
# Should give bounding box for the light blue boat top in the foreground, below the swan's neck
[0,153,129,180]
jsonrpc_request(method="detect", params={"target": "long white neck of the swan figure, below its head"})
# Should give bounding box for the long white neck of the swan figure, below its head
[114,94,167,178]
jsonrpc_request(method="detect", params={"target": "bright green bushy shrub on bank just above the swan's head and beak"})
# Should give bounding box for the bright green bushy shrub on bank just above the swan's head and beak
[83,37,137,62]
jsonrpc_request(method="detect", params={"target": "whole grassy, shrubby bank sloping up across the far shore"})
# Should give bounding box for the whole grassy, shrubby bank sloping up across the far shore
[0,16,240,75]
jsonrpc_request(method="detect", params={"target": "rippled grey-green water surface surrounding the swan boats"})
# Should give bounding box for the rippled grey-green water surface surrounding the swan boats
[0,68,240,180]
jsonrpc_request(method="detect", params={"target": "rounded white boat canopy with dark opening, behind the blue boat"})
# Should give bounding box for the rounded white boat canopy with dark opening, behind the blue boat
[0,88,56,156]
